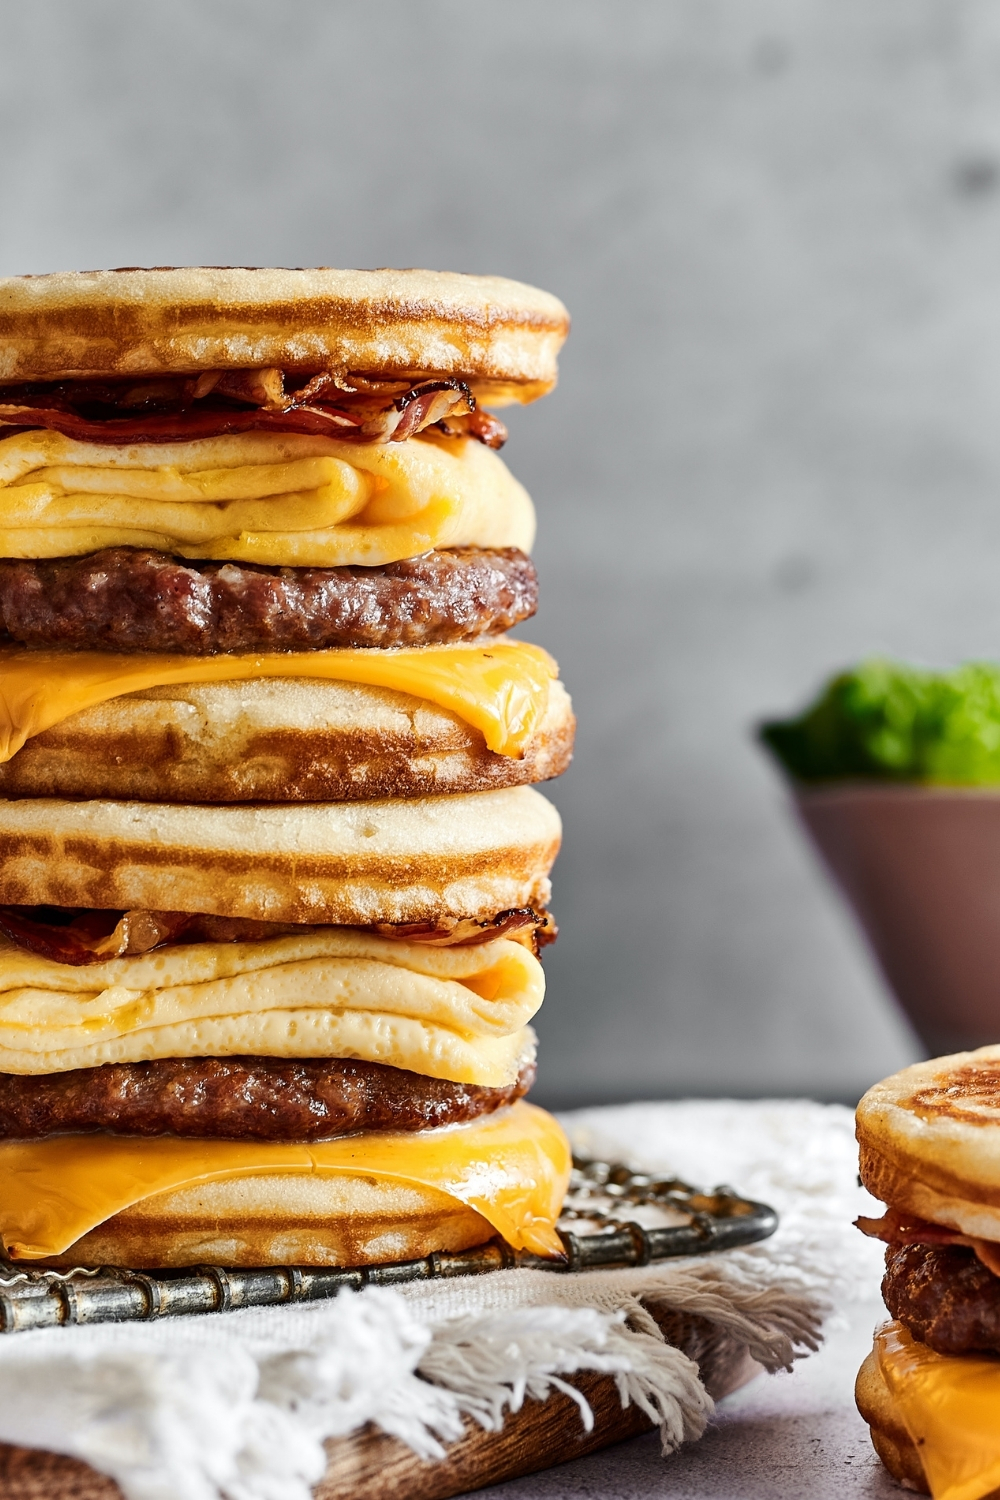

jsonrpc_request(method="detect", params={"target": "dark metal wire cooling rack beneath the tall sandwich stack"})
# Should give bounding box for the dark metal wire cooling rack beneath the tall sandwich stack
[0,1157,778,1334]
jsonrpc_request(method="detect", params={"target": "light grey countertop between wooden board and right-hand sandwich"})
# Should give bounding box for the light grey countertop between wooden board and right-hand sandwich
[464,1301,901,1500]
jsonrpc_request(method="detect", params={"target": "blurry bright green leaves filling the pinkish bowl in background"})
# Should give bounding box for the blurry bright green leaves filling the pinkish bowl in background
[760,660,1000,786]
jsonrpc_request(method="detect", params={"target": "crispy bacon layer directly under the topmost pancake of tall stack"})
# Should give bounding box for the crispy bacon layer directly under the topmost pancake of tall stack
[0,369,507,449]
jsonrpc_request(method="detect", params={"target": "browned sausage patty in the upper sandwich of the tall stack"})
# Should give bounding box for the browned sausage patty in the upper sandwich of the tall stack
[0,548,538,656]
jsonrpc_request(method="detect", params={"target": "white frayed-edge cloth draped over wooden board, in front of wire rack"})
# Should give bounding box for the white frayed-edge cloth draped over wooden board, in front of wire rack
[0,1274,820,1500]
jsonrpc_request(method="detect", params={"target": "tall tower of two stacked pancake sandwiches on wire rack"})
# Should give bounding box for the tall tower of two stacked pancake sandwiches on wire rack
[0,269,574,1268]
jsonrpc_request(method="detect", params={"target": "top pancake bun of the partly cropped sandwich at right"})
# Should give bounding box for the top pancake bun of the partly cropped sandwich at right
[858,1046,1000,1241]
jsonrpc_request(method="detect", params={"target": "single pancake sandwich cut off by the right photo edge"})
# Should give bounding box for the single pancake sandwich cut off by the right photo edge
[856,1047,1000,1500]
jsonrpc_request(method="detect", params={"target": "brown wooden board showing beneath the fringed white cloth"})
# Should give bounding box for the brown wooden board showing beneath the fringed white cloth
[0,1313,760,1500]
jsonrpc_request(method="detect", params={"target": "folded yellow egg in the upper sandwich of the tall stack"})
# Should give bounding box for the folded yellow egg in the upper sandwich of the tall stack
[0,432,535,567]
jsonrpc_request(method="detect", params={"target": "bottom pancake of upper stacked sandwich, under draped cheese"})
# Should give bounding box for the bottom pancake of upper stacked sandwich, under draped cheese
[0,678,576,803]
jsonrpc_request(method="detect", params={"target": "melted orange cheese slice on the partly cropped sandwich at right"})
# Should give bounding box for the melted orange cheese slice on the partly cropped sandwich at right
[876,1323,1000,1500]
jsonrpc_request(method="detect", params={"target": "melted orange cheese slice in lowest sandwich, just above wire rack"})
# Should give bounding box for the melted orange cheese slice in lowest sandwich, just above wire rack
[0,1103,570,1260]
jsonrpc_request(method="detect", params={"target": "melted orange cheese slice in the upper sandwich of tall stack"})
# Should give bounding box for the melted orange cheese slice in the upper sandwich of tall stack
[0,641,558,762]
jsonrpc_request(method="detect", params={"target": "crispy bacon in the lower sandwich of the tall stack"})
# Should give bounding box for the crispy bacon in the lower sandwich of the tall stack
[0,906,558,966]
